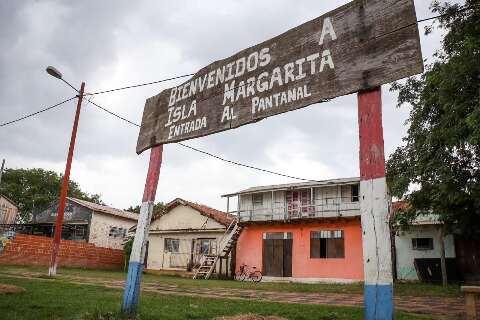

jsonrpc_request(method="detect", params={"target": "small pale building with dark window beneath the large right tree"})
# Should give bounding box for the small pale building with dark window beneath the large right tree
[392,201,458,280]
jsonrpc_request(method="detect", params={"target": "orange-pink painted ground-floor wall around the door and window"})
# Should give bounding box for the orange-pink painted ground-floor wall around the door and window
[236,219,363,280]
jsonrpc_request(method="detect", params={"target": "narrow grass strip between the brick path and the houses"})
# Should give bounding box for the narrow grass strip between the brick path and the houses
[0,265,461,297]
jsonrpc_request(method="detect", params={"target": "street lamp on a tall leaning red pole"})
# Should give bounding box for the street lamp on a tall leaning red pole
[46,66,85,276]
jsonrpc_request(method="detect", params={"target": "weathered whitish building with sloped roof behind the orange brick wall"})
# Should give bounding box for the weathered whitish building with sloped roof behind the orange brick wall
[35,197,138,249]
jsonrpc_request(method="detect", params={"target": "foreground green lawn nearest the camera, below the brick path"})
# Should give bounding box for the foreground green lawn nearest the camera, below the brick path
[0,276,433,320]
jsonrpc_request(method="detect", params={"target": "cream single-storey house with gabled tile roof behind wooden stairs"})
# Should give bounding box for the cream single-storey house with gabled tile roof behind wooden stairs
[147,198,234,271]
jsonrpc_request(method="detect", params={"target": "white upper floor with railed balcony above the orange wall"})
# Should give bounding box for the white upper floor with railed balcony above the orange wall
[223,178,360,222]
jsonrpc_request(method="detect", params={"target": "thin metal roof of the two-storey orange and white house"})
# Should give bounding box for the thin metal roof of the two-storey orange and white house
[222,177,360,197]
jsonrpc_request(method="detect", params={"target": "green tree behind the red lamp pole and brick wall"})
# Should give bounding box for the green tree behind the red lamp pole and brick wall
[0,168,103,222]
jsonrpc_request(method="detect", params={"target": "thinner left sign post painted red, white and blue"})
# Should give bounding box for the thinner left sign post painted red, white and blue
[122,145,163,314]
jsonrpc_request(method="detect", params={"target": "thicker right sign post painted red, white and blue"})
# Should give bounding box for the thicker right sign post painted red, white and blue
[358,87,393,320]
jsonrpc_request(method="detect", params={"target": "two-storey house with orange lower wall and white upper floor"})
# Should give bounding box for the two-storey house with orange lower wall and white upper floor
[224,178,363,282]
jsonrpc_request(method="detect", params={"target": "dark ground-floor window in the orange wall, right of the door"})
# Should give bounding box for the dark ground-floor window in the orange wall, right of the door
[310,230,345,259]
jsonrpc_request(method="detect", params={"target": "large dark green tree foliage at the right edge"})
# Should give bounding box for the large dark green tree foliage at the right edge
[387,0,480,237]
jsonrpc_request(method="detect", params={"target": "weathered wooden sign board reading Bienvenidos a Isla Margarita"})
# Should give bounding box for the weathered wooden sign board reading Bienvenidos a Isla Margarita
[137,0,423,153]
